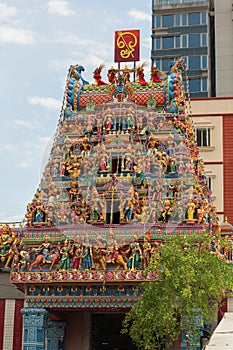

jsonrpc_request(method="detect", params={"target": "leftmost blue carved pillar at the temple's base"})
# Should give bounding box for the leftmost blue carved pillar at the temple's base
[21,307,47,350]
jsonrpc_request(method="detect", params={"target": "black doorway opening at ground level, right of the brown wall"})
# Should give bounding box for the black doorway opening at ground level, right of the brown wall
[91,313,137,350]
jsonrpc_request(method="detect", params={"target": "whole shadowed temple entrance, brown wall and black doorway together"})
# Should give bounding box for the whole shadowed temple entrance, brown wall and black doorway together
[50,310,137,350]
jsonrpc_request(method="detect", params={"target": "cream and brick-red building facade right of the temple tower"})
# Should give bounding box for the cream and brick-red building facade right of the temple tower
[191,97,233,223]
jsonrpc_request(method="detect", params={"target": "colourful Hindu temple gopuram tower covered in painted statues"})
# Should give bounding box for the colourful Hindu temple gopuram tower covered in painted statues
[0,47,224,350]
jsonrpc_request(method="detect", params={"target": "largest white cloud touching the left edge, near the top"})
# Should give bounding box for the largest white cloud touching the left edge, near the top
[0,25,35,44]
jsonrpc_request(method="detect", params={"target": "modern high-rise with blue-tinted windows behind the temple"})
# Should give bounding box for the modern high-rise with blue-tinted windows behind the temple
[151,0,233,98]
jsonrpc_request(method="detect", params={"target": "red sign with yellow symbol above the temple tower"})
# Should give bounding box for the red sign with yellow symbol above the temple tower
[114,30,140,62]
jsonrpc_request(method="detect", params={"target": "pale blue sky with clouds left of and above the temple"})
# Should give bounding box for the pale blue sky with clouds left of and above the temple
[0,0,151,222]
